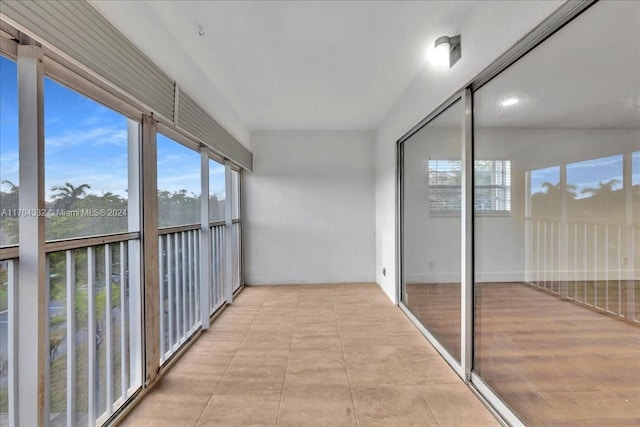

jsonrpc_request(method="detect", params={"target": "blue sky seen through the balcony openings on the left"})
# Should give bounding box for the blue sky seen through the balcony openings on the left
[0,57,224,200]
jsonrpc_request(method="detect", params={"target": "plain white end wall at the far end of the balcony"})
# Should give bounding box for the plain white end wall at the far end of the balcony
[244,131,375,285]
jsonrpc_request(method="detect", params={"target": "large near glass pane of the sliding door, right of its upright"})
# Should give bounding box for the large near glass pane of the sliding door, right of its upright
[473,2,640,426]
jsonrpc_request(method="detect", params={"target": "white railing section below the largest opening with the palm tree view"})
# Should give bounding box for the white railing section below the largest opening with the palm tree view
[46,233,142,426]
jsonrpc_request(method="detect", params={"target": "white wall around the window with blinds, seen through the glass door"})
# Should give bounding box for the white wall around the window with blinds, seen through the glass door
[404,126,525,283]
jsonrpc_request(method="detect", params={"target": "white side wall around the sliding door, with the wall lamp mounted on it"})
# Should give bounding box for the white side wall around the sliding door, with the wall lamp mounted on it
[375,1,563,301]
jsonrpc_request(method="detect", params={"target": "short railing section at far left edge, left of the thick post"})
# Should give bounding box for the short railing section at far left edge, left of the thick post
[0,258,18,427]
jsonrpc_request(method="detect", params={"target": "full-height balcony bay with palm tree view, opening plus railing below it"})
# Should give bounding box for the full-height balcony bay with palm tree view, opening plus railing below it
[41,76,141,426]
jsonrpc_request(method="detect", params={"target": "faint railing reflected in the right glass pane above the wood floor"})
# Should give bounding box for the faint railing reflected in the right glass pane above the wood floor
[525,218,640,322]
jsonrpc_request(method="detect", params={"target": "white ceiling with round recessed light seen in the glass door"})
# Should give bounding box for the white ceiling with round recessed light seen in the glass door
[475,1,640,130]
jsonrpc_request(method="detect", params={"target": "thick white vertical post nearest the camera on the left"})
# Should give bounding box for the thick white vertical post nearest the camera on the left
[15,45,49,426]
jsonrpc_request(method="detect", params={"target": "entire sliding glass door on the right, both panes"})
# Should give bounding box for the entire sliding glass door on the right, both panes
[399,2,640,426]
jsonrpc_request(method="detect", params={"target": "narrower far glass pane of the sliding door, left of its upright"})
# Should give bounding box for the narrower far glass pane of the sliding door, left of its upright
[402,100,463,363]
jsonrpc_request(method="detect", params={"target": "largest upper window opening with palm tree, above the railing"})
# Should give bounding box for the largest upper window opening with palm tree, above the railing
[44,78,134,240]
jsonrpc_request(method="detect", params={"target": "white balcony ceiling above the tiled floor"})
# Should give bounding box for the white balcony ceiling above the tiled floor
[94,1,477,129]
